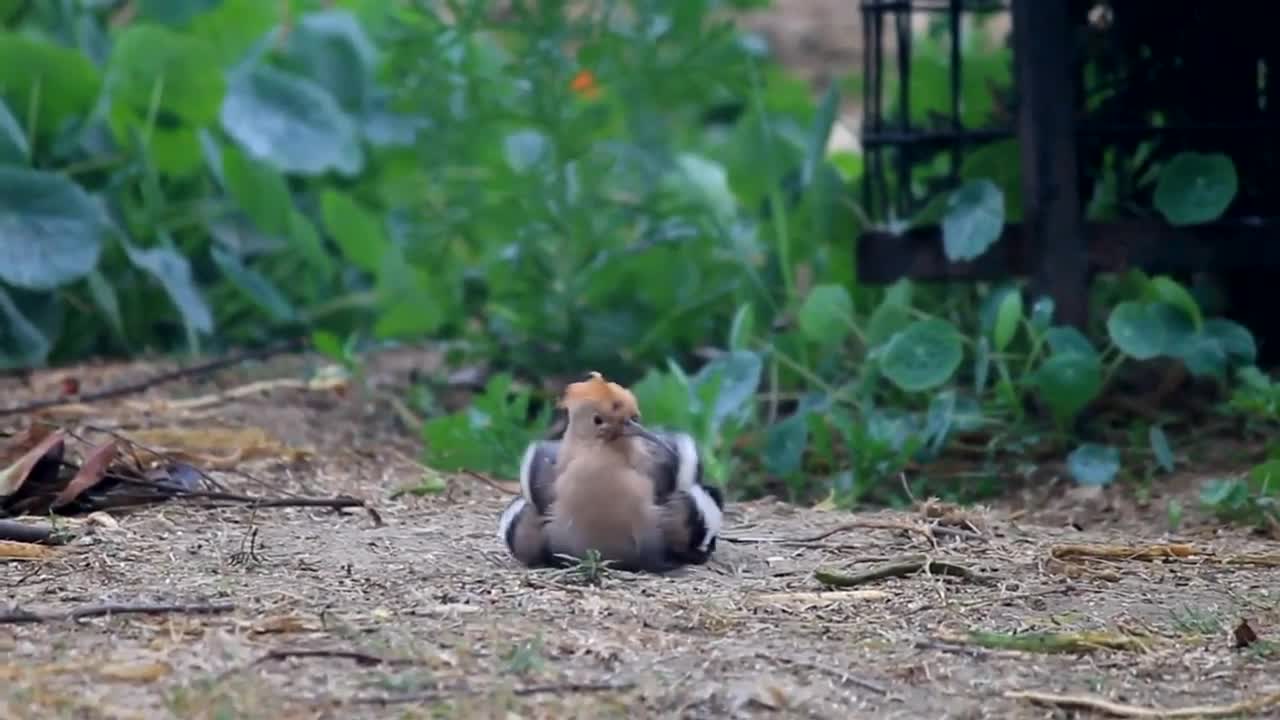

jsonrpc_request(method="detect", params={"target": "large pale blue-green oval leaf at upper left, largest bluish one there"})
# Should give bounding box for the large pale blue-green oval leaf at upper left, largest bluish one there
[221,65,365,176]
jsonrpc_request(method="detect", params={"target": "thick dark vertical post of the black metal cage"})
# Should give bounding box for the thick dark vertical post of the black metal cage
[1012,0,1088,327]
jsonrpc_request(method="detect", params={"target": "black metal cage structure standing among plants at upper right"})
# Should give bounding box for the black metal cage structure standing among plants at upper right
[859,0,1280,335]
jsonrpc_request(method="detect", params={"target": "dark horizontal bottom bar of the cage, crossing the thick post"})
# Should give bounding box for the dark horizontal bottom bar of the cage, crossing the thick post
[858,218,1280,284]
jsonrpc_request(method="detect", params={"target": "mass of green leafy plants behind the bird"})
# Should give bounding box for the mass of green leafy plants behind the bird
[0,0,1276,525]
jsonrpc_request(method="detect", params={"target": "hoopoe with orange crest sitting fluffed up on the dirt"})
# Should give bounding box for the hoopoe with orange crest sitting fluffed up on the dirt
[498,373,723,571]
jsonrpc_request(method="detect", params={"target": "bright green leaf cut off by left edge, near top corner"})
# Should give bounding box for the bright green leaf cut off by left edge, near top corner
[0,32,102,136]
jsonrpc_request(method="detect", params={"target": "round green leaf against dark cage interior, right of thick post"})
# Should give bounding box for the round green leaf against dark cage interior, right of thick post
[1153,152,1238,225]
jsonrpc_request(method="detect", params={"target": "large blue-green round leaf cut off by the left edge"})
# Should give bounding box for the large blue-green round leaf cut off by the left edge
[0,168,106,290]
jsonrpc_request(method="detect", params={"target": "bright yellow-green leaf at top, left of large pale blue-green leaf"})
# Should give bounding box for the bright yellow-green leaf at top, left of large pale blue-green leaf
[108,24,227,127]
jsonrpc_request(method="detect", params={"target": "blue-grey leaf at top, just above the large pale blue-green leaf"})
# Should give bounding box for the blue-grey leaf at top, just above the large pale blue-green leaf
[283,9,378,115]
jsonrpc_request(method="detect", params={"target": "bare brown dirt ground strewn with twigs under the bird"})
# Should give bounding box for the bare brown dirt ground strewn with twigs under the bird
[0,352,1280,719]
